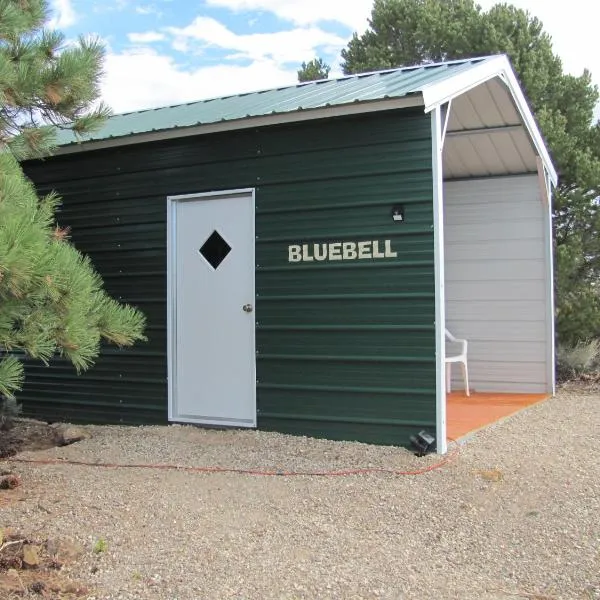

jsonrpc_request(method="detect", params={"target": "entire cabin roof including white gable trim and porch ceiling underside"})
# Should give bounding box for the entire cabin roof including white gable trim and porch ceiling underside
[57,55,558,185]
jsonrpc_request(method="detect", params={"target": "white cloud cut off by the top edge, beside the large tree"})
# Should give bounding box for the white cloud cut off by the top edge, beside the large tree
[206,0,373,33]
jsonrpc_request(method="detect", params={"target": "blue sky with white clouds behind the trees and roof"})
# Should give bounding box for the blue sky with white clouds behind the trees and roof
[50,0,600,115]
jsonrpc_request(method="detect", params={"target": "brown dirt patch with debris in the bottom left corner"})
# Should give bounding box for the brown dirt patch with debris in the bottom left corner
[0,530,88,600]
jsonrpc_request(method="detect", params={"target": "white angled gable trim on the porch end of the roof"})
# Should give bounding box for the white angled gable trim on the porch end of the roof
[421,55,558,187]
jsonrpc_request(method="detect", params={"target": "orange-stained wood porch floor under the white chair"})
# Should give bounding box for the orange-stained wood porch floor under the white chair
[446,391,549,440]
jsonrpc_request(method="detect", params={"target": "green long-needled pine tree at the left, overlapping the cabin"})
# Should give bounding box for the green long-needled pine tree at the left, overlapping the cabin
[0,0,145,404]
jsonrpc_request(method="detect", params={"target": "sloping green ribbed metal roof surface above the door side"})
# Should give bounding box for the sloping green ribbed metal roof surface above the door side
[58,57,494,146]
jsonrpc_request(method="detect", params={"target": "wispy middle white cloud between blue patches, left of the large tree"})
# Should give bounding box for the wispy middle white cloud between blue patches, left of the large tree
[168,17,346,63]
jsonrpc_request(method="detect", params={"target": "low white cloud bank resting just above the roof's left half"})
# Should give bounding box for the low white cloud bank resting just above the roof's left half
[102,48,297,113]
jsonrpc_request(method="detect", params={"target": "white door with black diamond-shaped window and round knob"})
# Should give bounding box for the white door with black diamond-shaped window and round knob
[168,190,256,427]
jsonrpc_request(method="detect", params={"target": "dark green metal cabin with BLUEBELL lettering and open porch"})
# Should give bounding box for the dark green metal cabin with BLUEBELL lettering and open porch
[21,56,556,453]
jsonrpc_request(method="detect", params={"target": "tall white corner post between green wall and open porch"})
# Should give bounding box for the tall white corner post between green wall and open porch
[431,106,448,454]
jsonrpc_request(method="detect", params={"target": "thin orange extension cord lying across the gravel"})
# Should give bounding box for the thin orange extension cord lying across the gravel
[7,440,460,477]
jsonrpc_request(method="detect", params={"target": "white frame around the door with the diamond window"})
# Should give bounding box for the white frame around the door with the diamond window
[167,188,257,427]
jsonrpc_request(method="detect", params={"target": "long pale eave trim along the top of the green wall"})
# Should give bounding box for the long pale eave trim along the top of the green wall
[52,93,423,156]
